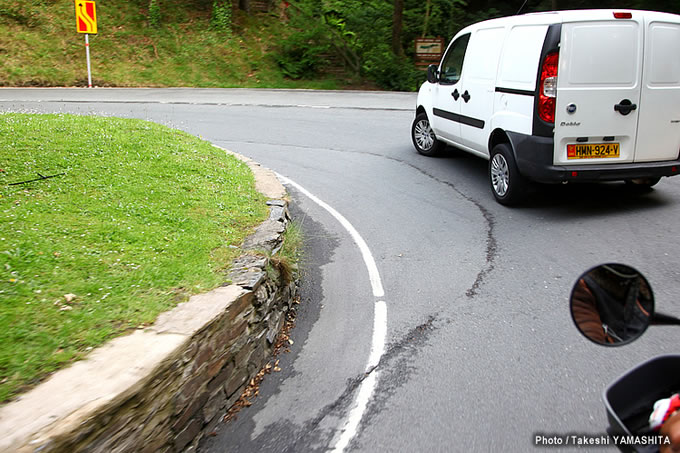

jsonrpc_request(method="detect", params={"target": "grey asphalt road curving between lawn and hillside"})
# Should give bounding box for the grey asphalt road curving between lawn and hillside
[0,89,680,452]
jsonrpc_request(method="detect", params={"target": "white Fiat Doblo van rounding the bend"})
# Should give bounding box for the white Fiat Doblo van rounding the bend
[411,10,680,205]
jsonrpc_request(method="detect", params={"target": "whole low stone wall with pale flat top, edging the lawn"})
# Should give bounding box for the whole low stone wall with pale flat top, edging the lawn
[0,196,296,453]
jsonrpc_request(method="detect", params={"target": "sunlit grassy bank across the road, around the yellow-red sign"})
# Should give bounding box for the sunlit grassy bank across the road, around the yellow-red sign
[0,0,356,89]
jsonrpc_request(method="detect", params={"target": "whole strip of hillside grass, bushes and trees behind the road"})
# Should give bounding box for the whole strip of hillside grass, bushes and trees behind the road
[0,0,680,90]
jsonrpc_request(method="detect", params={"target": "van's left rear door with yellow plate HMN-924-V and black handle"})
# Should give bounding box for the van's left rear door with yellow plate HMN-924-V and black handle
[553,12,644,165]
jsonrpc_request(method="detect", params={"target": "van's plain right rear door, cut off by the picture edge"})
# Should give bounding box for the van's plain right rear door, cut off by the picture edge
[635,15,680,162]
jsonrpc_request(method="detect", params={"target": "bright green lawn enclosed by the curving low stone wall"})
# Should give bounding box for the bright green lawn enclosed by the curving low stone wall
[0,114,267,402]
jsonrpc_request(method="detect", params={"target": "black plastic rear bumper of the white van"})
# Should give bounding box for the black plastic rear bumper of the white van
[508,132,680,183]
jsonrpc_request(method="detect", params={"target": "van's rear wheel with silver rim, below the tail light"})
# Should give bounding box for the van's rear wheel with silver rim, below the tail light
[489,143,528,206]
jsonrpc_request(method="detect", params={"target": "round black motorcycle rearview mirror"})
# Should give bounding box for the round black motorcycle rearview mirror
[569,263,656,346]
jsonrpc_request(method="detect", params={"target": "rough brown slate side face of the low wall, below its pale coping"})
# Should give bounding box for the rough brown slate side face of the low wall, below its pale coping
[19,200,297,453]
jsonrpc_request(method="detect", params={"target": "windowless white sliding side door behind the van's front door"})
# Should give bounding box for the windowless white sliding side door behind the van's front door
[458,26,506,157]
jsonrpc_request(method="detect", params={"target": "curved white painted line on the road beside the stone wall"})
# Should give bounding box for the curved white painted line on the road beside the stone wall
[276,173,387,453]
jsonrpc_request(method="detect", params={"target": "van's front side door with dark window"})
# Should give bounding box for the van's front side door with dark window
[430,33,470,143]
